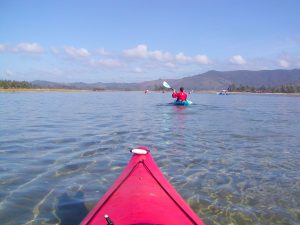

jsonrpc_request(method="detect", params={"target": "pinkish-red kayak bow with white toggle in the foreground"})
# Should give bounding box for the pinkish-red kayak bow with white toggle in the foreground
[80,147,204,225]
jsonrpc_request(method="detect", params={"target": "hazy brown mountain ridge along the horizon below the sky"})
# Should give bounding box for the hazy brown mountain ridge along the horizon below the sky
[31,69,300,91]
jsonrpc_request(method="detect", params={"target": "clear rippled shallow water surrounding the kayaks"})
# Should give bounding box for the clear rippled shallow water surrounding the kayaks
[0,92,300,225]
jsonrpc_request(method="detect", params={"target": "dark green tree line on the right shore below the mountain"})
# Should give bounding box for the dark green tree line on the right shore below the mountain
[227,84,300,93]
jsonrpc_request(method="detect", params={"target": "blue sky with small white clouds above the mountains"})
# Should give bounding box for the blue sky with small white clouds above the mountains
[0,0,300,83]
